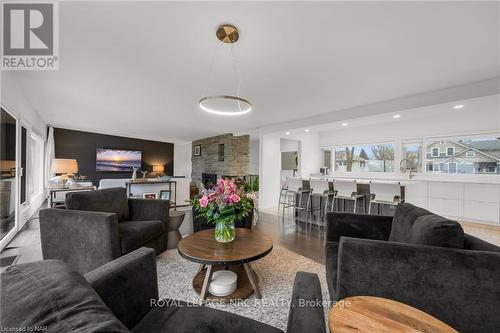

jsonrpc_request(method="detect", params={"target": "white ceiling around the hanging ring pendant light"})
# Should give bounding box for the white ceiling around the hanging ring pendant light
[2,2,500,141]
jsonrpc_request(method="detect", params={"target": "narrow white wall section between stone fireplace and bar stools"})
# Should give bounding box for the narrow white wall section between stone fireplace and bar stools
[259,134,281,209]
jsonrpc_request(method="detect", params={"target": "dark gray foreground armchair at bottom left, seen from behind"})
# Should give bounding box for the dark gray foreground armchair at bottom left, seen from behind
[0,248,325,333]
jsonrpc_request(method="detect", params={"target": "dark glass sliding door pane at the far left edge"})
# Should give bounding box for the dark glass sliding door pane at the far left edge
[0,109,18,240]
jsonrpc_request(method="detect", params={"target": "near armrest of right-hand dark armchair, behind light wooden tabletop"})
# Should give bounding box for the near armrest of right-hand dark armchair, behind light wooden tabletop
[337,238,500,332]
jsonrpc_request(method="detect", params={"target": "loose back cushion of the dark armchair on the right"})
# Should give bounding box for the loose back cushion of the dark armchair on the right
[389,203,464,249]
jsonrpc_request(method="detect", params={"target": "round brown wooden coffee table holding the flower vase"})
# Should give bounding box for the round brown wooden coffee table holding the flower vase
[178,228,273,301]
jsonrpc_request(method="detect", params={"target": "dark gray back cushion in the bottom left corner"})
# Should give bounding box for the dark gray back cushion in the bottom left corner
[1,260,129,333]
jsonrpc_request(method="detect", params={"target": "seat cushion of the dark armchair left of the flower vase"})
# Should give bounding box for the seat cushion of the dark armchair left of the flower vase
[118,220,164,254]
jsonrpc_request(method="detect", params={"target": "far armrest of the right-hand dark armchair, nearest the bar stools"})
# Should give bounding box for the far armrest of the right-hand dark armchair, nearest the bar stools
[326,213,392,242]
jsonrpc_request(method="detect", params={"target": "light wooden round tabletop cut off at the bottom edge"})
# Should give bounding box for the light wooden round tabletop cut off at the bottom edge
[328,296,458,333]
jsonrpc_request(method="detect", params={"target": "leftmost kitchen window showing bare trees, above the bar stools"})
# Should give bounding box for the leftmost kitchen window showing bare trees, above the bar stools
[335,143,395,172]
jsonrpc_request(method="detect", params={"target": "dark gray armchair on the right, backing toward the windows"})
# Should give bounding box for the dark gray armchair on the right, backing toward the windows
[325,204,500,333]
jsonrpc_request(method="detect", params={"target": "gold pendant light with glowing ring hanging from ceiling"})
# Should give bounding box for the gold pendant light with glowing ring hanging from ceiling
[198,24,252,116]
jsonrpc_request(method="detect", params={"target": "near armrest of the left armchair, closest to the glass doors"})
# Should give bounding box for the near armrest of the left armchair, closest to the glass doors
[40,208,121,273]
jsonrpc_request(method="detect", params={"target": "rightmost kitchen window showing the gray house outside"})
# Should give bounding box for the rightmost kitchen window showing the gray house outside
[426,137,500,174]
